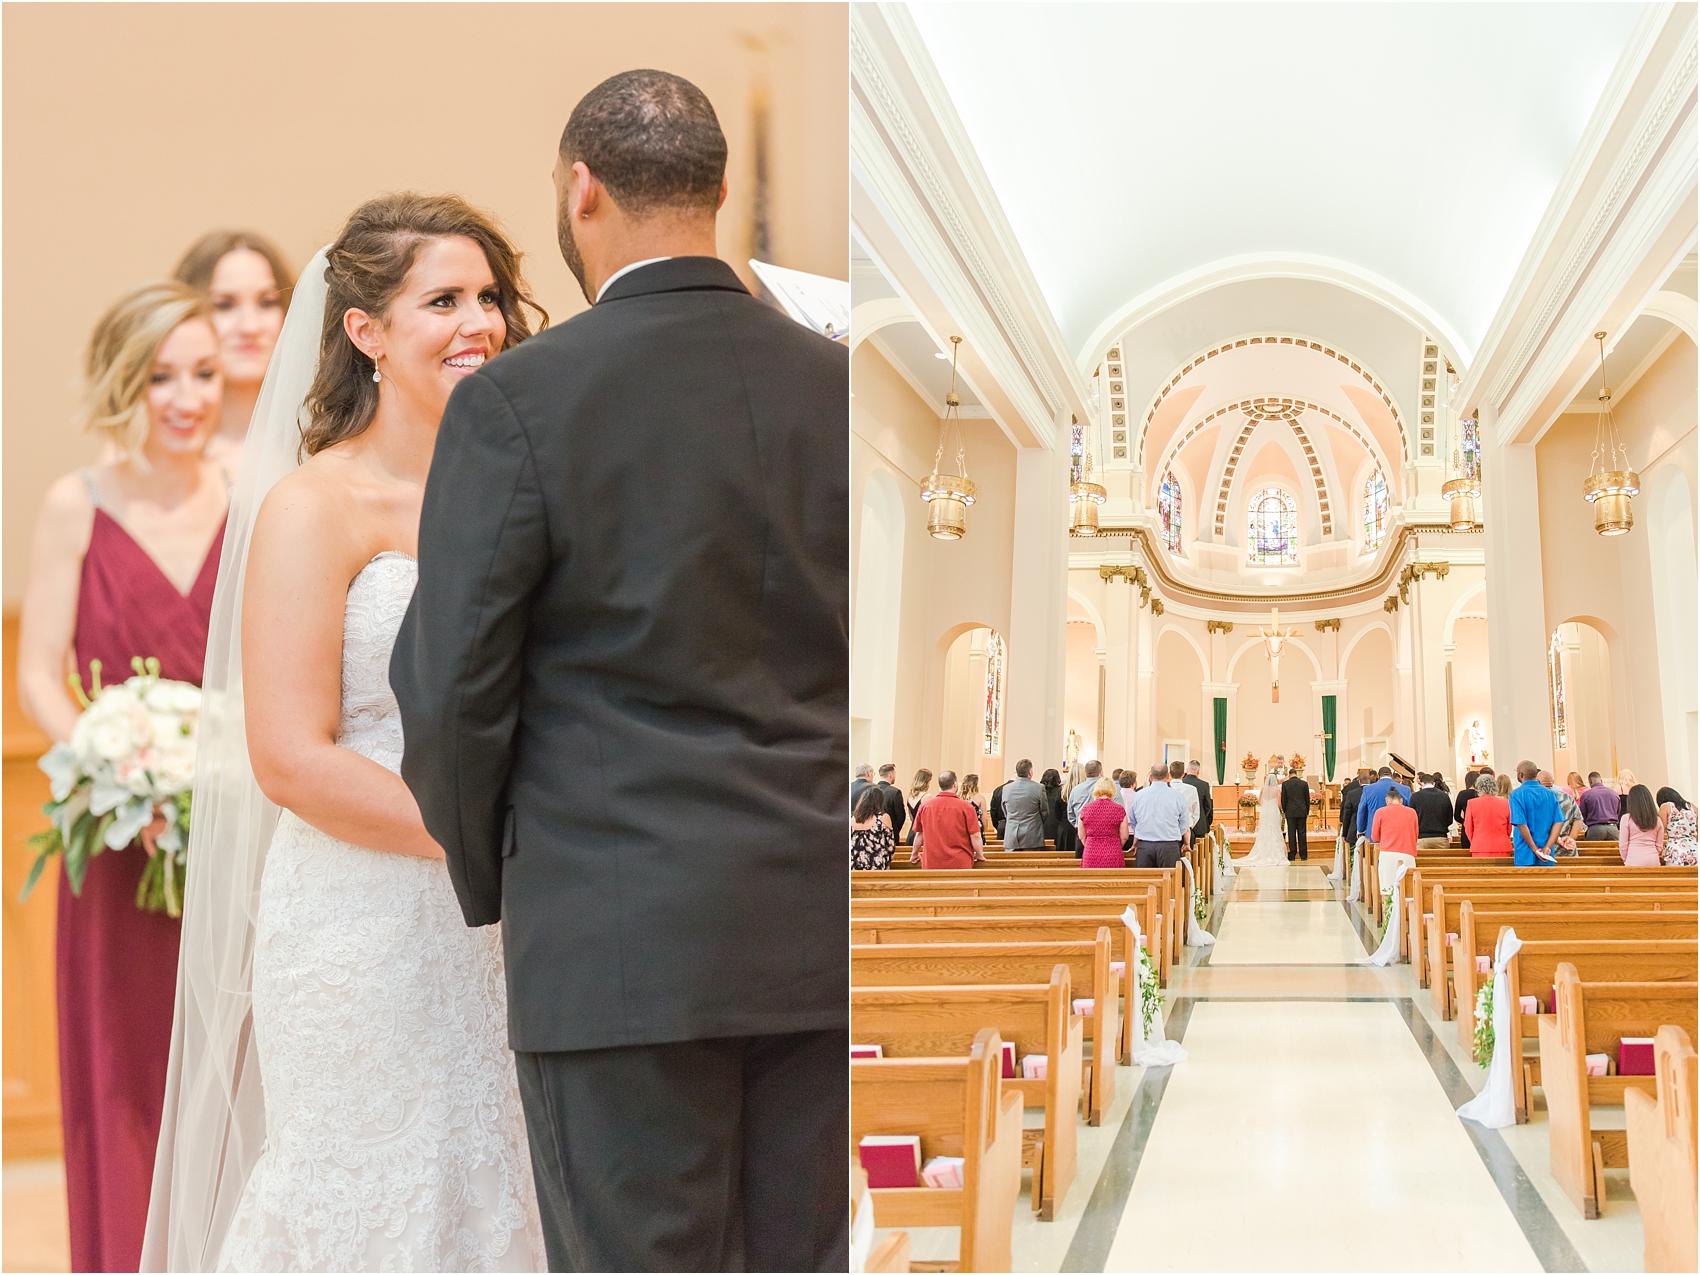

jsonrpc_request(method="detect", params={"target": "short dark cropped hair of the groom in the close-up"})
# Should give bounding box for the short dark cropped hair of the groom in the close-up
[561,71,726,214]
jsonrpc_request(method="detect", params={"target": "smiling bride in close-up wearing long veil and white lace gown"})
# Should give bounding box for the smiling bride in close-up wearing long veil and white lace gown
[143,194,546,1270]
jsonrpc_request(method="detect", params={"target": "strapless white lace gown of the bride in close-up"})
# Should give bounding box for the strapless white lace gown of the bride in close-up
[219,553,547,1272]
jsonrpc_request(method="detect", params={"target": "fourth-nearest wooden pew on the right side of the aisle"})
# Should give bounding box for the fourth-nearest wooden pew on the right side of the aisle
[1406,867,1700,1018]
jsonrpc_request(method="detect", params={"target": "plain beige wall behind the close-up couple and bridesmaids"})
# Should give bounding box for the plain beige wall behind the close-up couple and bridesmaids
[0,3,848,605]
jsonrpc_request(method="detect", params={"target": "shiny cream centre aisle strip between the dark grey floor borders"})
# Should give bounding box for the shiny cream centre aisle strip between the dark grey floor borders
[1076,865,1542,1272]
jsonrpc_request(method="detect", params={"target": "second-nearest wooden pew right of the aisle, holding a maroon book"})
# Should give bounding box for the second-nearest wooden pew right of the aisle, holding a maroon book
[1540,962,1700,1217]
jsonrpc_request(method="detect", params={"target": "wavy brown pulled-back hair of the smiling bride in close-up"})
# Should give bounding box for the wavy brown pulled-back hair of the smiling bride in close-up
[301,190,549,456]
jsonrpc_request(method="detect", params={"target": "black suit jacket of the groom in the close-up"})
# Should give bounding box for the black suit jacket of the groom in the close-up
[389,257,850,1052]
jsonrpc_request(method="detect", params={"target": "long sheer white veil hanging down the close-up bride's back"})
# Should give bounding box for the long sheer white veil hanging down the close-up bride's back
[141,248,326,1270]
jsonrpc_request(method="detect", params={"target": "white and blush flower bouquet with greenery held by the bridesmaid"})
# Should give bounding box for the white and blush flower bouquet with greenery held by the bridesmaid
[19,660,201,916]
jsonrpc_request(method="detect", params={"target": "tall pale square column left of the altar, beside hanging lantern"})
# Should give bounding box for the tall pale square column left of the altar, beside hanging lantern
[999,438,1069,767]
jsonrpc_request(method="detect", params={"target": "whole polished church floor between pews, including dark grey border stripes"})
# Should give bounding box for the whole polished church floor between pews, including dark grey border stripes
[870,857,1641,1272]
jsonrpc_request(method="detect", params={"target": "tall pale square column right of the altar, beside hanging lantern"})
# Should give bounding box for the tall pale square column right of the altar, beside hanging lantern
[1481,405,1557,772]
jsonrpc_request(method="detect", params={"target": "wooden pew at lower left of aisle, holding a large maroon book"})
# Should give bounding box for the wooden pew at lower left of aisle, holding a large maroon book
[850,1027,1022,1272]
